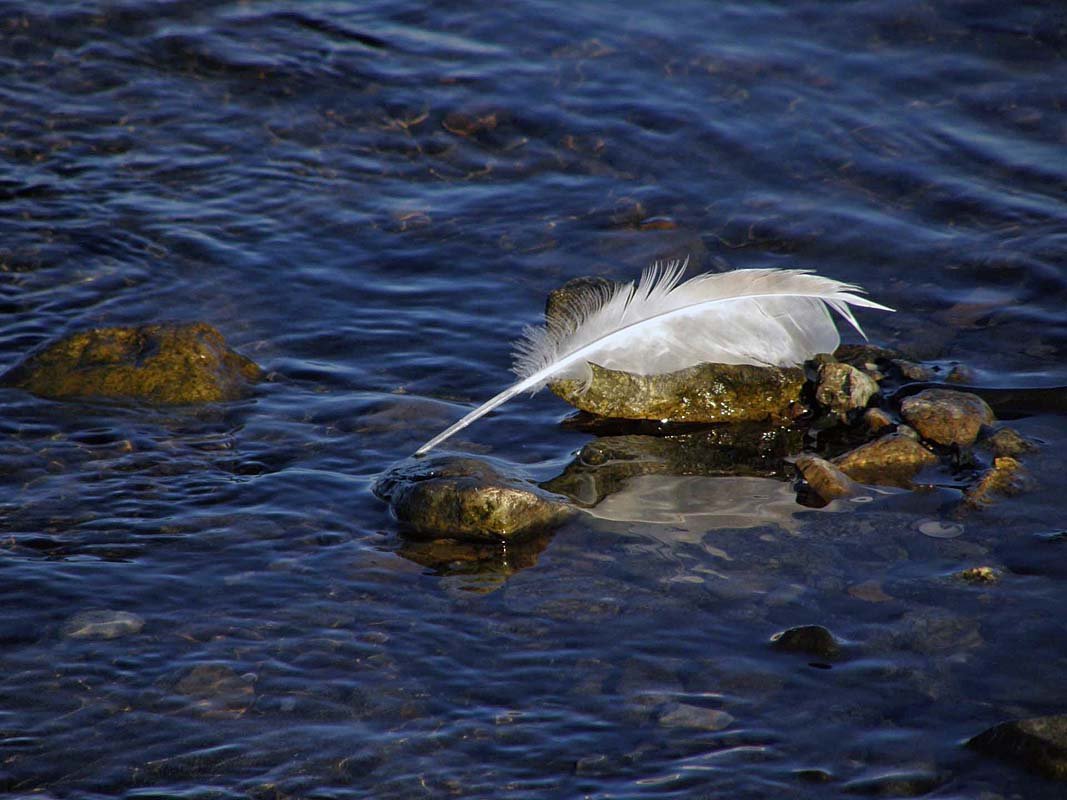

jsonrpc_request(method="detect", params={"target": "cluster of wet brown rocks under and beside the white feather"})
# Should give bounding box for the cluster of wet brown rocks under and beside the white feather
[376,278,1033,542]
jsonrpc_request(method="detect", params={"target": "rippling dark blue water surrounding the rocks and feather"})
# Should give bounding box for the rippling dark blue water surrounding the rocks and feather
[0,0,1067,798]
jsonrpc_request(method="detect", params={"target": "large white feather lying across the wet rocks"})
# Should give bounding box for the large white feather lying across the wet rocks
[415,261,893,455]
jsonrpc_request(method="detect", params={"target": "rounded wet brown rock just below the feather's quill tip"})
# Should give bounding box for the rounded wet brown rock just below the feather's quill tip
[373,457,574,542]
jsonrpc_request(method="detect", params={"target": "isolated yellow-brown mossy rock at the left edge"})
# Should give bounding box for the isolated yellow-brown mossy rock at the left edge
[0,322,260,404]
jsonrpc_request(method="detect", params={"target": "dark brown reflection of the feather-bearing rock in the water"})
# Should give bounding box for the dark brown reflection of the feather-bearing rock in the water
[541,423,803,507]
